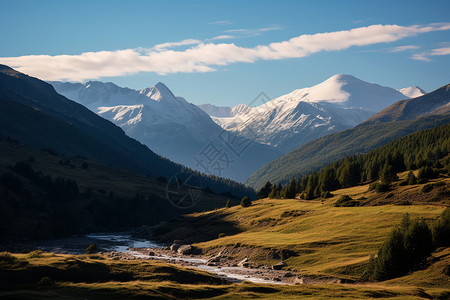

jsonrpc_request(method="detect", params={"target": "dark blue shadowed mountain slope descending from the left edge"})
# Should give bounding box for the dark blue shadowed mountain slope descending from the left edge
[0,65,252,196]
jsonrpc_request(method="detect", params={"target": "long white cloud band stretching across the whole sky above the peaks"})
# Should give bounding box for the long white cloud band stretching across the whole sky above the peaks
[0,23,450,81]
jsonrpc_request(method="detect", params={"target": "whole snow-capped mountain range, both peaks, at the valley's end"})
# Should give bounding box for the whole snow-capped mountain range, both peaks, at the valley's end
[50,75,423,182]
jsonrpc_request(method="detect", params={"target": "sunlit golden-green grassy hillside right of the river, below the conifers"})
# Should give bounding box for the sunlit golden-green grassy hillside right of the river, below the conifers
[153,173,450,287]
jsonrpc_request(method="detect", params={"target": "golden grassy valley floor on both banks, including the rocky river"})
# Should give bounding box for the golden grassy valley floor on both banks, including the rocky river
[0,174,450,299]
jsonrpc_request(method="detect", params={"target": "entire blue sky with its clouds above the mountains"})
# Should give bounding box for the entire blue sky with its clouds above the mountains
[0,0,450,105]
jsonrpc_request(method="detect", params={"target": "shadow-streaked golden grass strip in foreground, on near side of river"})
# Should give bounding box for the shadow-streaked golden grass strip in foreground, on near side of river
[0,249,450,299]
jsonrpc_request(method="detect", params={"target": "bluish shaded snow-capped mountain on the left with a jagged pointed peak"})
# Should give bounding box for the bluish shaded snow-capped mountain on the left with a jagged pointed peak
[50,81,280,182]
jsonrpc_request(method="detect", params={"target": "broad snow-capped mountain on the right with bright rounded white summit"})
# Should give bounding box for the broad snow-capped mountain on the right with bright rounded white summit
[203,75,412,153]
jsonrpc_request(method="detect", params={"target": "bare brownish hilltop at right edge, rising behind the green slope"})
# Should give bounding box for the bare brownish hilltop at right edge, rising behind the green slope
[361,84,450,125]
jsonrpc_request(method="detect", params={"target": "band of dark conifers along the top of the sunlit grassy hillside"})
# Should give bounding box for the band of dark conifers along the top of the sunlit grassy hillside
[258,124,450,200]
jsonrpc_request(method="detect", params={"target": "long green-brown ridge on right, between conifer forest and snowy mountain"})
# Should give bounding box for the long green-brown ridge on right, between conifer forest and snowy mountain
[247,85,450,188]
